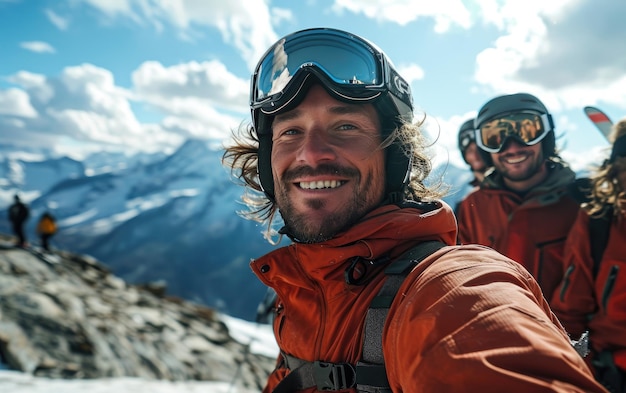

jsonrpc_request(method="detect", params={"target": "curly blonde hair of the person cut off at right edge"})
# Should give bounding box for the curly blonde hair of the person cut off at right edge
[583,118,626,217]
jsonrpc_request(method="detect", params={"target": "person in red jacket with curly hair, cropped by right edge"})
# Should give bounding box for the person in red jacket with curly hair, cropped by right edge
[552,118,626,392]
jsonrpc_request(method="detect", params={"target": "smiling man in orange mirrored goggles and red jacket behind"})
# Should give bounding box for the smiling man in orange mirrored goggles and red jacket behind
[457,93,579,299]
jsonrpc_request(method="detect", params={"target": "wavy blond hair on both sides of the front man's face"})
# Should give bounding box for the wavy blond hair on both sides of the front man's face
[222,117,448,242]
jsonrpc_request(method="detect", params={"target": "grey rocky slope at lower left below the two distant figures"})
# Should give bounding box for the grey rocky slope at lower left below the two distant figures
[0,236,274,389]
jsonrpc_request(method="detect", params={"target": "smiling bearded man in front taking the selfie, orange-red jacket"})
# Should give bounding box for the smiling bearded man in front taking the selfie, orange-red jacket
[223,29,603,393]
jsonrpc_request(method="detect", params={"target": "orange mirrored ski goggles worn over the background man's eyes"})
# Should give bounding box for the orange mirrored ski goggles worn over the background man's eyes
[476,112,553,153]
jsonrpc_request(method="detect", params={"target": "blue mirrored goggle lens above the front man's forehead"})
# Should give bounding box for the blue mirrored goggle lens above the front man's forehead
[252,30,383,104]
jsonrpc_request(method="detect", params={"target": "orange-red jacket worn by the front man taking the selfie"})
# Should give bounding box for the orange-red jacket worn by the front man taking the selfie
[251,201,604,393]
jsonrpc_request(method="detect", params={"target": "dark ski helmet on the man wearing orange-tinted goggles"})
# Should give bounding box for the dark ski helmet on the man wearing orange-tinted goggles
[474,93,557,166]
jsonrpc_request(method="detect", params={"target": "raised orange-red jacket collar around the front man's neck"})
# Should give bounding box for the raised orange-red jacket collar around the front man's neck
[251,201,457,286]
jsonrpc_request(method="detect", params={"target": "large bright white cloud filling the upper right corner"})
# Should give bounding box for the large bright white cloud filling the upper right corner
[475,0,626,109]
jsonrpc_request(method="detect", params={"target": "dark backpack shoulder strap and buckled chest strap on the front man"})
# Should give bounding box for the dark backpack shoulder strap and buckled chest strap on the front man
[272,240,445,393]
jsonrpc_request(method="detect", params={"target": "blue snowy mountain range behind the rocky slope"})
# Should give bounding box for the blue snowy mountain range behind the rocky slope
[0,140,471,320]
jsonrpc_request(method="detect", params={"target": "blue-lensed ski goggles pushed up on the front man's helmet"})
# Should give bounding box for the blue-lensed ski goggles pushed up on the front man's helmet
[250,28,413,133]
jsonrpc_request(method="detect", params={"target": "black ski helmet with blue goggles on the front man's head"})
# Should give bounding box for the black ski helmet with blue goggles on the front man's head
[250,28,413,201]
